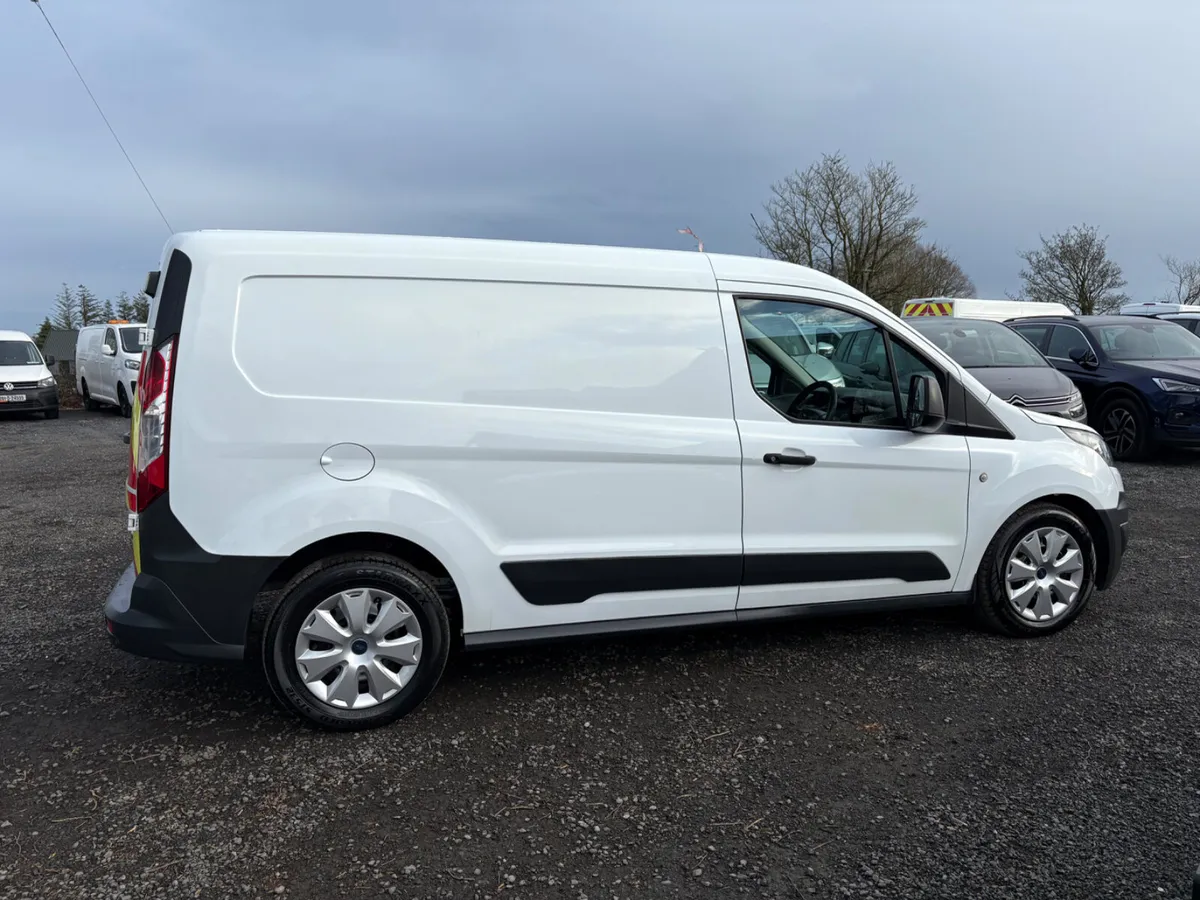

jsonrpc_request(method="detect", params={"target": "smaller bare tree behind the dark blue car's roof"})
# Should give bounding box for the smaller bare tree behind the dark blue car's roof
[1019,224,1129,316]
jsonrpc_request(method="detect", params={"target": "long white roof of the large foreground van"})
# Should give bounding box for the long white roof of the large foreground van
[163,230,864,298]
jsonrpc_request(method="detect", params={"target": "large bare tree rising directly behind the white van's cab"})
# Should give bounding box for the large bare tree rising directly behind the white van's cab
[751,154,973,308]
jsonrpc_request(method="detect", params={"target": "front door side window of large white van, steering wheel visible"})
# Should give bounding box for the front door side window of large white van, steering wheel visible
[736,298,936,427]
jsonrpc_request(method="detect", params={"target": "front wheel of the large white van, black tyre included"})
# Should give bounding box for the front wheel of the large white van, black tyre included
[976,504,1097,637]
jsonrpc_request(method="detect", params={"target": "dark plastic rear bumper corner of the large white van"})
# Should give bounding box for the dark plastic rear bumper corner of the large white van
[104,564,245,662]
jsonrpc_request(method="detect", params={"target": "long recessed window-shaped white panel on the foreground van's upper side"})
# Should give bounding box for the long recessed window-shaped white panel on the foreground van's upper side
[234,276,732,418]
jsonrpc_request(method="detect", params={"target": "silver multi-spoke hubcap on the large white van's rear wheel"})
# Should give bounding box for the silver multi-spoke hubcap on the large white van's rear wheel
[295,588,421,709]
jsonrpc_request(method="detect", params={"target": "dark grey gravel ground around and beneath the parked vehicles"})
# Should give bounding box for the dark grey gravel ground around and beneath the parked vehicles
[0,413,1200,900]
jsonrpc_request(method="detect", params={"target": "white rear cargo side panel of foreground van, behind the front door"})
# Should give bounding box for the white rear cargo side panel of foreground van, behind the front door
[170,266,742,632]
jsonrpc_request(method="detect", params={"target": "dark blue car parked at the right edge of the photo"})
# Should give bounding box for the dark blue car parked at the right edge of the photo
[1007,316,1200,460]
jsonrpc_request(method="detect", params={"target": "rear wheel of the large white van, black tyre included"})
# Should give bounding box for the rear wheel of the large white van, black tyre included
[262,554,451,731]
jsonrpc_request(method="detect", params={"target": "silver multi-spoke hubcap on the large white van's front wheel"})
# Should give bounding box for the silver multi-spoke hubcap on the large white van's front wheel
[1004,527,1084,625]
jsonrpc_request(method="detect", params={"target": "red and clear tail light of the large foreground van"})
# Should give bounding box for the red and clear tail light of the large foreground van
[126,337,176,512]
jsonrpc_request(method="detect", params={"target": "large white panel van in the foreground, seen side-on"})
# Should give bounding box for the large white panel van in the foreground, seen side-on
[104,232,1127,728]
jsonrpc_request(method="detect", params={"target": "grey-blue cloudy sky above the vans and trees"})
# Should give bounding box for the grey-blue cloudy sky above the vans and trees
[0,0,1200,330]
